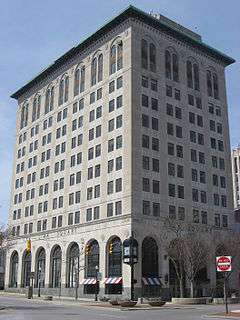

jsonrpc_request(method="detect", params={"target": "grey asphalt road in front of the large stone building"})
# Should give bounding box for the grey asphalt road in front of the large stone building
[0,295,240,320]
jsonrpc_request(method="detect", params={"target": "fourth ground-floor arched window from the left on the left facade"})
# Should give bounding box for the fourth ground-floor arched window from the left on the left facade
[50,246,62,288]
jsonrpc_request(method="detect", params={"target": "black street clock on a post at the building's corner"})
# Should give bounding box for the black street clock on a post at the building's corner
[123,236,138,301]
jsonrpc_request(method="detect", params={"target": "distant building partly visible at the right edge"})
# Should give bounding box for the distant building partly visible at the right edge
[232,146,240,209]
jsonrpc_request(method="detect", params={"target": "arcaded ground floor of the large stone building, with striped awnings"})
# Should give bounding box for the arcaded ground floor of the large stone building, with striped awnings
[5,220,236,300]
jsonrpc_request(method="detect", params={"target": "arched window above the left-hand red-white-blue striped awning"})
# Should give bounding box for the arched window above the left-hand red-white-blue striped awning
[85,240,99,278]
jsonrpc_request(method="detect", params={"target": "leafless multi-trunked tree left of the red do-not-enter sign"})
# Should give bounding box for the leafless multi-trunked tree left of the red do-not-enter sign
[162,218,211,297]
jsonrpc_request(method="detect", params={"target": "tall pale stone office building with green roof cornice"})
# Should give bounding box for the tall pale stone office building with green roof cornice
[6,6,234,295]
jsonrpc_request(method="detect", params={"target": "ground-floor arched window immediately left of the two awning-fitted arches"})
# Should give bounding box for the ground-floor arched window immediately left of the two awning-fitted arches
[67,243,79,288]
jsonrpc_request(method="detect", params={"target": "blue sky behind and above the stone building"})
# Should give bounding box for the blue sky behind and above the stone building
[0,0,240,222]
